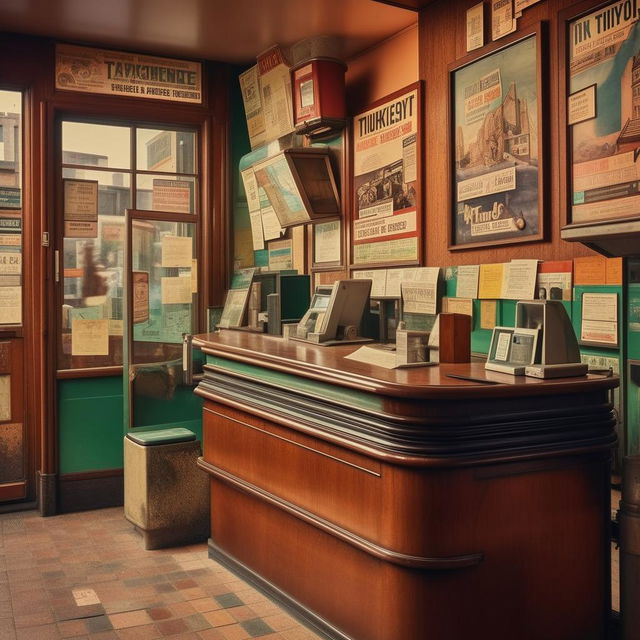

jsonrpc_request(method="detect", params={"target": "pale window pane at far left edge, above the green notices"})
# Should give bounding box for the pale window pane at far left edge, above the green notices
[0,91,22,209]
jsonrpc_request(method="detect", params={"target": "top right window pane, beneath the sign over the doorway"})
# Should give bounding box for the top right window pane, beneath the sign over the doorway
[136,129,196,173]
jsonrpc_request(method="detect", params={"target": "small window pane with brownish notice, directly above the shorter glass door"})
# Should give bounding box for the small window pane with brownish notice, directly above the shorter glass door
[136,173,197,213]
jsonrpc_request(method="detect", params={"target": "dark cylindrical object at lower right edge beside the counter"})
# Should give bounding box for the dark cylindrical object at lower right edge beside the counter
[618,455,640,640]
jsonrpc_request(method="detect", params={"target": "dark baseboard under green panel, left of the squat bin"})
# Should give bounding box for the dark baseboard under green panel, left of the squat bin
[57,469,124,513]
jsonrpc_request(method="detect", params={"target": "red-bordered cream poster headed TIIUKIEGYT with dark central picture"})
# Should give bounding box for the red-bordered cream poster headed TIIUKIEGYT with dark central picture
[351,83,422,266]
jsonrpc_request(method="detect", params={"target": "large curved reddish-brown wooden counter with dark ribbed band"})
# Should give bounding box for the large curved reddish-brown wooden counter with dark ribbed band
[194,331,618,640]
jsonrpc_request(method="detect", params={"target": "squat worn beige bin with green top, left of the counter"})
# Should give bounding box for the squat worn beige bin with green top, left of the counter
[124,428,209,549]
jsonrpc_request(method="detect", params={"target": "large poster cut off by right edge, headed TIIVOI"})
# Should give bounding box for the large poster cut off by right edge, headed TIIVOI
[568,0,640,223]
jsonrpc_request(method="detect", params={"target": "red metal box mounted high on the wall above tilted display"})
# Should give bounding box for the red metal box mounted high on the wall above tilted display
[291,58,347,136]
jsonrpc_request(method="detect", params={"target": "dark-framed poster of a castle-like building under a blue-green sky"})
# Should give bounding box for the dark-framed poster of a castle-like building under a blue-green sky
[449,25,545,249]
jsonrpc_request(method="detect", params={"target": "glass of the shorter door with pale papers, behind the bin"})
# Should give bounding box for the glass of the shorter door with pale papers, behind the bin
[129,220,197,427]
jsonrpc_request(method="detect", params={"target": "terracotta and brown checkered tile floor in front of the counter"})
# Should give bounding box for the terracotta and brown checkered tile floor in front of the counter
[0,509,318,640]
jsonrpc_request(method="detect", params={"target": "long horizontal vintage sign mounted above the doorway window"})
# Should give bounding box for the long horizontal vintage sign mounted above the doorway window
[55,44,202,104]
